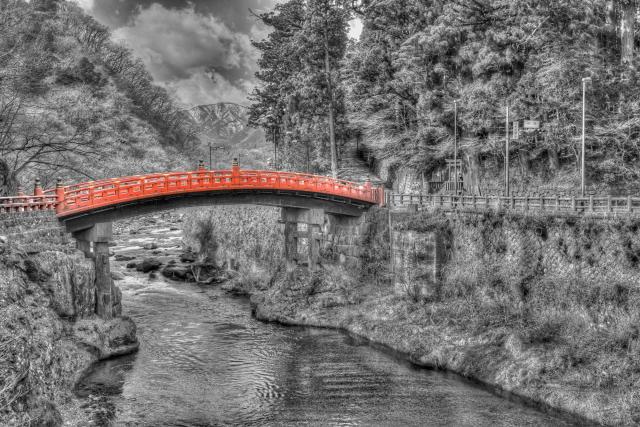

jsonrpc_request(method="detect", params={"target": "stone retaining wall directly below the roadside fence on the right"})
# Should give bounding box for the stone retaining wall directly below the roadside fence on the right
[393,212,640,318]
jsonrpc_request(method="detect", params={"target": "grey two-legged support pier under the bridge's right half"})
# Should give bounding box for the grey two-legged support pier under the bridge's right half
[282,208,324,271]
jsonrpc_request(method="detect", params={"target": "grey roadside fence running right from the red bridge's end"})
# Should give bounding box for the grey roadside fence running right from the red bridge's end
[388,193,640,214]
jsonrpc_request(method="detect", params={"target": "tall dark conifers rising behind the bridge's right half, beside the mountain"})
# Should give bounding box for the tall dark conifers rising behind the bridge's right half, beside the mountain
[249,0,349,172]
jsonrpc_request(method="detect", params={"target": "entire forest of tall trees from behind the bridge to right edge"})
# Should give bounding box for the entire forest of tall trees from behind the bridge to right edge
[251,0,640,194]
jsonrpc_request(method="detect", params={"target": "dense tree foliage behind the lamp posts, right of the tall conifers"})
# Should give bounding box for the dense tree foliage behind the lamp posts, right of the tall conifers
[345,0,640,191]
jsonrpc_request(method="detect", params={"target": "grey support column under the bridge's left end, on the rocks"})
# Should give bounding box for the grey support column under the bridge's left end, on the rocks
[73,222,113,320]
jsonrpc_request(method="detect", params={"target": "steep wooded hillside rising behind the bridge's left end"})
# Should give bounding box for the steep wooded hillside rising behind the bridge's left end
[0,0,197,196]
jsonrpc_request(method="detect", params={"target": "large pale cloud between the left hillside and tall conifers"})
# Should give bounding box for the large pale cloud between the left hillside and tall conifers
[114,3,257,106]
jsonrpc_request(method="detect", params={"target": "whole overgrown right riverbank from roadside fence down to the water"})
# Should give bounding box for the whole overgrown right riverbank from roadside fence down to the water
[191,206,640,425]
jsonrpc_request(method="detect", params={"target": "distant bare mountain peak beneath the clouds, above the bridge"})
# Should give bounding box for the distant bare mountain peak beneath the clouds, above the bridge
[185,102,271,169]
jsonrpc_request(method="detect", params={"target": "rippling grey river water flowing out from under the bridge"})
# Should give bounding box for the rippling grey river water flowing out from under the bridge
[78,222,580,426]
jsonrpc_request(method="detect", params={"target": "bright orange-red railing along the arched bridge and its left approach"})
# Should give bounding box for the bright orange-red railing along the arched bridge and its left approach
[0,166,384,217]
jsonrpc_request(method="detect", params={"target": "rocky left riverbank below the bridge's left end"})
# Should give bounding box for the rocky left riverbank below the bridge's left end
[0,213,138,426]
